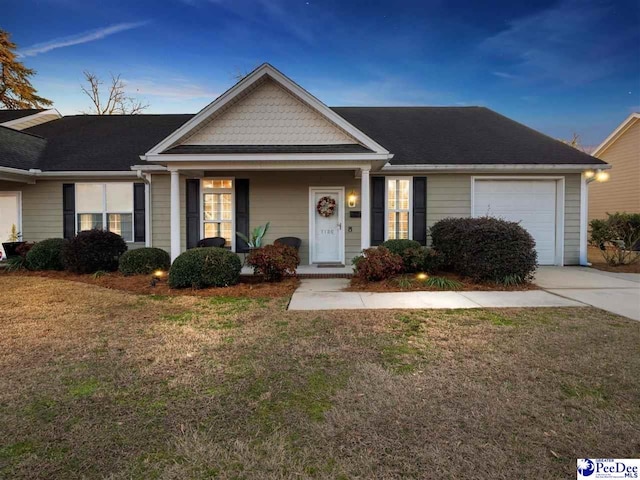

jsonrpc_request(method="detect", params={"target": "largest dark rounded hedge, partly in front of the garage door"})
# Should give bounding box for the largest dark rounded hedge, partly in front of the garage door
[431,217,537,283]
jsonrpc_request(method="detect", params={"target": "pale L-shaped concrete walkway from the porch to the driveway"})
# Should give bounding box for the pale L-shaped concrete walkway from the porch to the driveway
[289,278,584,310]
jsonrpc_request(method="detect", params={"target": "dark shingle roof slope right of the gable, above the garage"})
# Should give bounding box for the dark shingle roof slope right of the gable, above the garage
[332,107,605,165]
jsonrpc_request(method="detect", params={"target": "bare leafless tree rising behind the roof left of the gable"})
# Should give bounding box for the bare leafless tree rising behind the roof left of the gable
[81,71,149,115]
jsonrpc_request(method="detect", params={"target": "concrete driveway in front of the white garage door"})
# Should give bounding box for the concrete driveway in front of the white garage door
[535,267,640,320]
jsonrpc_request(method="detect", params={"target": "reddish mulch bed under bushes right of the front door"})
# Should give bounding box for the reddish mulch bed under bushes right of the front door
[346,272,539,292]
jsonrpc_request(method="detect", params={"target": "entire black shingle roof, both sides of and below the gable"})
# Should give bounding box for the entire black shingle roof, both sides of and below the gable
[0,107,604,171]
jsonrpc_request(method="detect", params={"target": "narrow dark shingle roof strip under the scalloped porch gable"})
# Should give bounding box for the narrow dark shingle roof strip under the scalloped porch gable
[162,143,371,154]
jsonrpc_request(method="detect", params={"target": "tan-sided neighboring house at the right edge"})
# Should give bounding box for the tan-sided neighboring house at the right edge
[589,113,640,220]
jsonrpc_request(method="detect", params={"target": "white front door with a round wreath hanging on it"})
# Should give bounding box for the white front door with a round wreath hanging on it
[309,187,344,263]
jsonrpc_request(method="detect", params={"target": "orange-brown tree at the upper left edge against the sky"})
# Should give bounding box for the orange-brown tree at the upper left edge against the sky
[0,30,53,110]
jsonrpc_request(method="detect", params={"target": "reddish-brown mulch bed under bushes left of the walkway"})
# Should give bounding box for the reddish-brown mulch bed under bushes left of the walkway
[0,270,299,298]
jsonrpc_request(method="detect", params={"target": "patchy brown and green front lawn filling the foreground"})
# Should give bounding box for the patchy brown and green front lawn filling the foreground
[0,276,640,479]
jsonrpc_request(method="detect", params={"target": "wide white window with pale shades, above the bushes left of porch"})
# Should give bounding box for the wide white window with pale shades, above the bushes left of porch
[76,183,133,242]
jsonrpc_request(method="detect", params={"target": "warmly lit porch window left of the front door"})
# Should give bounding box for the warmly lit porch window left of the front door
[202,178,235,249]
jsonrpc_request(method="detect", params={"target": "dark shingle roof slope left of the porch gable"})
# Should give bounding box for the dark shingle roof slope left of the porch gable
[26,114,193,171]
